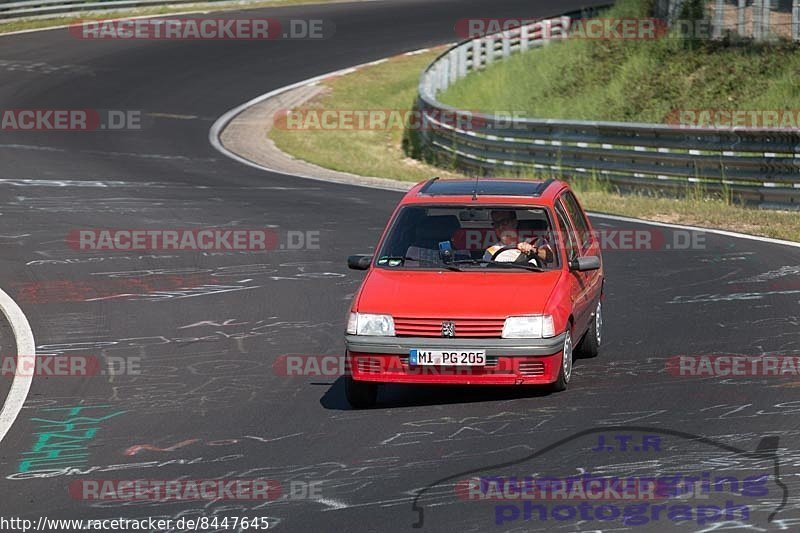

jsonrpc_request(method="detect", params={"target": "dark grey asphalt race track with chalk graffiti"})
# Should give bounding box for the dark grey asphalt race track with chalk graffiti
[0,0,800,532]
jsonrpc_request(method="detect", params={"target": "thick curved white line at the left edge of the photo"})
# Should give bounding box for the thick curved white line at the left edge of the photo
[0,289,36,442]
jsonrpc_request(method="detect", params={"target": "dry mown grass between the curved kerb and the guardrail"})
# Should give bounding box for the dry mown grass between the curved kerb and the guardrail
[269,46,800,241]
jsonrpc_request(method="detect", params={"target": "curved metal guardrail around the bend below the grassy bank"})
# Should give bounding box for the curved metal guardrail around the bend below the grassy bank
[417,10,800,209]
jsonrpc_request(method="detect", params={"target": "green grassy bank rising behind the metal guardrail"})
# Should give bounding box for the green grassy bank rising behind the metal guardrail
[439,0,800,123]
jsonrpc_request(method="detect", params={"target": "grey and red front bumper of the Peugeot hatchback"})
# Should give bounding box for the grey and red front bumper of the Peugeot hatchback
[345,333,564,385]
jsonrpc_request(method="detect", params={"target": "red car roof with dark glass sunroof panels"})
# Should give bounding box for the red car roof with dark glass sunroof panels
[401,178,569,206]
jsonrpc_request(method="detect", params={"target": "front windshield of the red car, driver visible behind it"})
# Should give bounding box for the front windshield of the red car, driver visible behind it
[376,206,559,272]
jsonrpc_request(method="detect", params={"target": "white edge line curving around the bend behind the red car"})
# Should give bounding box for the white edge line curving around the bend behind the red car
[208,53,800,248]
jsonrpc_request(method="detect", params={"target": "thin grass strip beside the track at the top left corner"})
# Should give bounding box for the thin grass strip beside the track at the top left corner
[0,0,358,35]
